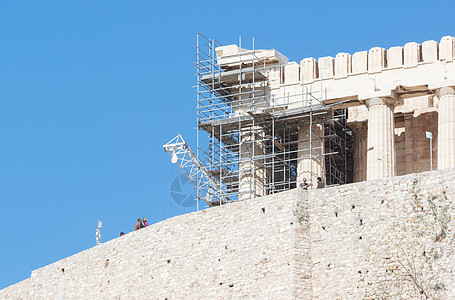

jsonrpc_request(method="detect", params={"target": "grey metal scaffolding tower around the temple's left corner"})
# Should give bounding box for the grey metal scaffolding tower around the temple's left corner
[196,34,353,204]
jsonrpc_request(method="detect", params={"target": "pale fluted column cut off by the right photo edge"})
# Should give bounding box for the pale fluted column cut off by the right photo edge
[436,87,455,169]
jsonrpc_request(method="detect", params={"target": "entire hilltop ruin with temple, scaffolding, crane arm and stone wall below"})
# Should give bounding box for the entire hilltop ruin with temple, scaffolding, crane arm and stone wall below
[0,35,455,299]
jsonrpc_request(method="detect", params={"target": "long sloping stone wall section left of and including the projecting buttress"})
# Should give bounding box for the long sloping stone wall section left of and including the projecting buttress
[0,190,311,299]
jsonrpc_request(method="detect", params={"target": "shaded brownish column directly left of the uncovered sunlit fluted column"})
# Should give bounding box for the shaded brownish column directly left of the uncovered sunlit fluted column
[349,122,368,182]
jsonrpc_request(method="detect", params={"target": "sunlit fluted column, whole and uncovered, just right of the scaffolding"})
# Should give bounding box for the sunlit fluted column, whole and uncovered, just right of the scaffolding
[365,97,396,180]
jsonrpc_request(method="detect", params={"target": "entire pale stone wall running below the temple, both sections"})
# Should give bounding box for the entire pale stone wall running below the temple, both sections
[0,169,455,299]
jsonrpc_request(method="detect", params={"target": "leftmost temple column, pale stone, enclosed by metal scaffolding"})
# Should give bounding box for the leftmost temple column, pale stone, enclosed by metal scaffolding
[239,128,266,200]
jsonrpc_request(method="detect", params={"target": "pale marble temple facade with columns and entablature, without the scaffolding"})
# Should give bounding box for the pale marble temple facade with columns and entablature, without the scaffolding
[210,36,455,198]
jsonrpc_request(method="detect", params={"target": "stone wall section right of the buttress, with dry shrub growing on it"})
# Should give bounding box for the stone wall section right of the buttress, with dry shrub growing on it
[309,169,455,299]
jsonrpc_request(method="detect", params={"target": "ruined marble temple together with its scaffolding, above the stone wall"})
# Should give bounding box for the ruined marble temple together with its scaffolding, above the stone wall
[196,35,455,206]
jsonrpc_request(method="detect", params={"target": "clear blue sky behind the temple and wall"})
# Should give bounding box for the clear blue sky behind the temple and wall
[0,0,455,289]
